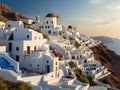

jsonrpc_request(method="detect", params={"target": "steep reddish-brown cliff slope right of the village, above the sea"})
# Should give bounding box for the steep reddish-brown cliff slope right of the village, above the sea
[91,44,120,89]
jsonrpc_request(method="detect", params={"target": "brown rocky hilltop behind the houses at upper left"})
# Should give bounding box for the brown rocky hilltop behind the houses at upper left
[0,3,28,22]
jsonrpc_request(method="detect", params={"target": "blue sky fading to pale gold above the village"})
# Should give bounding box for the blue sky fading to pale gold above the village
[0,0,120,38]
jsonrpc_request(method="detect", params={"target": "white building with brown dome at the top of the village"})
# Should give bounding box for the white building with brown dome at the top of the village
[30,13,62,36]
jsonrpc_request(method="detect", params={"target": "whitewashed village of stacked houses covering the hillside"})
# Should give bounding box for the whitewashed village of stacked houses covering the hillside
[0,13,114,90]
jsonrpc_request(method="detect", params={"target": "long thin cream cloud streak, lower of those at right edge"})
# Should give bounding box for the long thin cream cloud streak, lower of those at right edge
[80,18,120,25]
